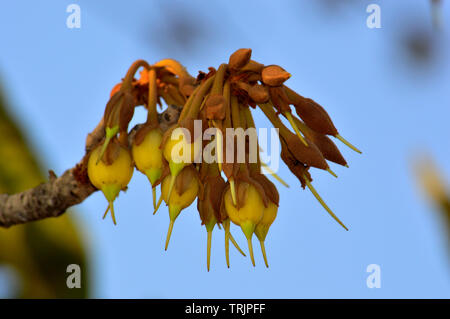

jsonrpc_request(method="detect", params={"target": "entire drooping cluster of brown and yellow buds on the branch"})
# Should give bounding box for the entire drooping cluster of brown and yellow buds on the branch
[87,49,359,270]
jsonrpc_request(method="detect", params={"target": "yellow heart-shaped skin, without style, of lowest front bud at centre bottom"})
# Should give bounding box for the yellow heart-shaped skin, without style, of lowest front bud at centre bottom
[224,185,265,238]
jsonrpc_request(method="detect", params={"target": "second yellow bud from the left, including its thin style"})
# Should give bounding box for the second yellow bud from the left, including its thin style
[131,125,163,208]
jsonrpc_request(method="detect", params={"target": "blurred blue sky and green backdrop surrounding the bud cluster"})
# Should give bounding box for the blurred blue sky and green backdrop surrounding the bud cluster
[0,0,450,298]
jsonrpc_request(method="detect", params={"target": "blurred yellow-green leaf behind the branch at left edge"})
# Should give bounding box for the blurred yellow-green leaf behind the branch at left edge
[0,86,89,298]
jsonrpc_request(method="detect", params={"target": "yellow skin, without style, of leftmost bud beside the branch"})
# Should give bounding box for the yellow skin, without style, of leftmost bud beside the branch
[88,146,133,201]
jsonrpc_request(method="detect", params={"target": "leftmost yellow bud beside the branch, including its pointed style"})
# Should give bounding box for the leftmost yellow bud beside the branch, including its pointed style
[88,139,133,224]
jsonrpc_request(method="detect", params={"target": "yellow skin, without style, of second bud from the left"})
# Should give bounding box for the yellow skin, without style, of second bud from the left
[131,129,163,185]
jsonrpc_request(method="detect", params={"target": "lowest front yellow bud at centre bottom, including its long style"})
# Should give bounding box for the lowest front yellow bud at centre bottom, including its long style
[223,182,265,266]
